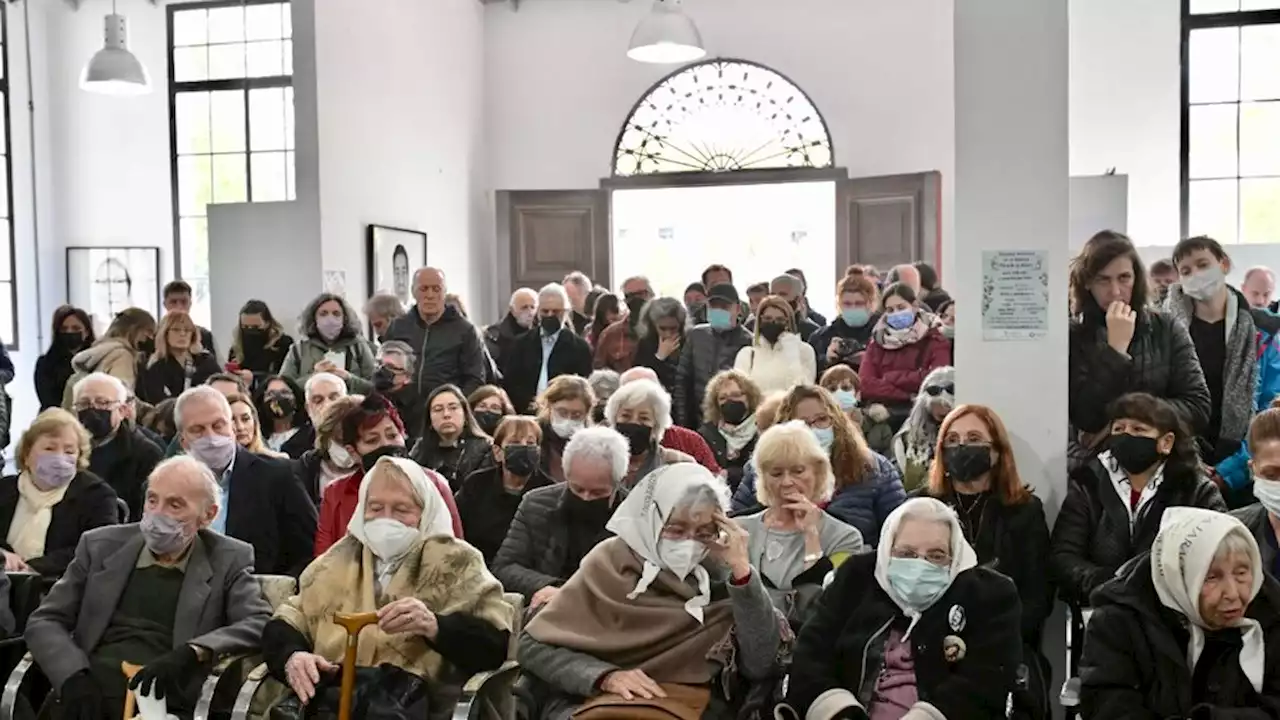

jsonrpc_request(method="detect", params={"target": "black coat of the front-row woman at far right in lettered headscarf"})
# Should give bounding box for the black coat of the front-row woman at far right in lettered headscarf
[1080,556,1280,720]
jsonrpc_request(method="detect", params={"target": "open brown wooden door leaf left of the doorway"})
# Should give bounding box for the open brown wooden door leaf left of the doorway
[498,190,612,298]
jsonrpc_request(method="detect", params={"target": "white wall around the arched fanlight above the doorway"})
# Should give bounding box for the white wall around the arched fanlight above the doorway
[485,0,955,278]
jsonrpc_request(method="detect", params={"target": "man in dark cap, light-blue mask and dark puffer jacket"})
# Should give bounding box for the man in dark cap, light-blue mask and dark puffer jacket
[671,283,751,430]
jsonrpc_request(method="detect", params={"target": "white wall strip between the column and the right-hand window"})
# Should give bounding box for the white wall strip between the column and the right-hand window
[1070,0,1181,246]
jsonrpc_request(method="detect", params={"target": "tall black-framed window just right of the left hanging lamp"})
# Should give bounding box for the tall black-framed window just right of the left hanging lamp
[169,0,296,324]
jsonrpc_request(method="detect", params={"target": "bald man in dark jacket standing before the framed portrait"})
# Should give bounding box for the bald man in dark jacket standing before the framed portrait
[385,268,486,398]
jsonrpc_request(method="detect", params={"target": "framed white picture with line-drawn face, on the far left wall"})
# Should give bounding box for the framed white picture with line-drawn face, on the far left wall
[67,242,160,333]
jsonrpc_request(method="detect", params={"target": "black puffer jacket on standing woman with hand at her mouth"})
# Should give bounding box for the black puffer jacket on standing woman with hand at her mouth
[1068,306,1212,434]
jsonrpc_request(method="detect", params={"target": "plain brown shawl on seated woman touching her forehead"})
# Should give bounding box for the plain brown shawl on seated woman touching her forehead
[526,538,733,685]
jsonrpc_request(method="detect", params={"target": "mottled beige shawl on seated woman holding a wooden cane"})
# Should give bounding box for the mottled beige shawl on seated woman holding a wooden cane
[275,536,511,682]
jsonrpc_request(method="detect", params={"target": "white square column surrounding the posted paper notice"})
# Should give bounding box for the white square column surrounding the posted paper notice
[948,0,1069,520]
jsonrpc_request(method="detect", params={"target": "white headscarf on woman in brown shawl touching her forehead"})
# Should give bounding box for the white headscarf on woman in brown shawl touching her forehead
[604,462,728,623]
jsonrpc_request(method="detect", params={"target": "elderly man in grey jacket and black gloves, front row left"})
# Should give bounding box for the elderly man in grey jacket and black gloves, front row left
[26,456,271,720]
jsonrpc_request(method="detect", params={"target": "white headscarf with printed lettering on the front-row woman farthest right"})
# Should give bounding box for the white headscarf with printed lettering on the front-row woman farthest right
[1151,507,1266,693]
